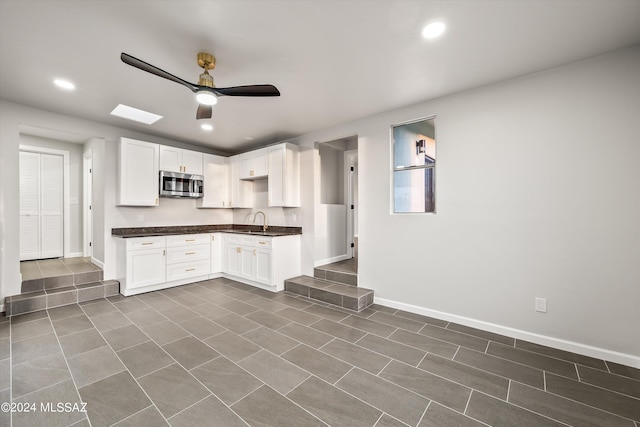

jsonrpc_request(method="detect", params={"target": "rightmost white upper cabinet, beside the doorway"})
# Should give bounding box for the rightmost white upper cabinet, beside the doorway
[267,143,300,207]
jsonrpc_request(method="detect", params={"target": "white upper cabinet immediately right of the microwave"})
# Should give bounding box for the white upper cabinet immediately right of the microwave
[196,154,231,208]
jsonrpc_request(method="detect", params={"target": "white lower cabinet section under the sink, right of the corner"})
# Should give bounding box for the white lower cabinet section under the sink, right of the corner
[222,233,300,292]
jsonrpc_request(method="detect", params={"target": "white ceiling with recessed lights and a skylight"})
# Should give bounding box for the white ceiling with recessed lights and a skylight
[0,0,640,152]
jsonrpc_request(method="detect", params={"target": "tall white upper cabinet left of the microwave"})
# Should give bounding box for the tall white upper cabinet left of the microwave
[117,138,160,206]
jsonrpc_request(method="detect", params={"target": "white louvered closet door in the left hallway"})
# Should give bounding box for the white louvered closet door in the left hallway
[20,151,64,261]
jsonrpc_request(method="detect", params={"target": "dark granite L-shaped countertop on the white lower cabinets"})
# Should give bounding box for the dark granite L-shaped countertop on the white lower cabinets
[111,224,302,238]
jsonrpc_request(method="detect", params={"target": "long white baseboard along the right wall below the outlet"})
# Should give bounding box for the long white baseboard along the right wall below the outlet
[373,297,640,368]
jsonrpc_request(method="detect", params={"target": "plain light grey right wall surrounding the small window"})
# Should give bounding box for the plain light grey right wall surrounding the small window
[293,47,640,367]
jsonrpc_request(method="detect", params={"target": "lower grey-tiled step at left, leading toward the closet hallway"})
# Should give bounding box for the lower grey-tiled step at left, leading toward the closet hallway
[4,280,120,317]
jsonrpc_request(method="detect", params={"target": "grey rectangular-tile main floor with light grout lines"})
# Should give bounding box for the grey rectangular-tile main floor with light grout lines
[0,279,640,427]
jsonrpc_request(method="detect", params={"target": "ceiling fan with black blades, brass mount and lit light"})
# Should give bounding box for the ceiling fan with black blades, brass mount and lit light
[120,52,280,119]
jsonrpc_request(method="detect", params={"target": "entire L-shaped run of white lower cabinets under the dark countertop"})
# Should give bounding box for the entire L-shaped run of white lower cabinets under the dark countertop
[116,233,300,296]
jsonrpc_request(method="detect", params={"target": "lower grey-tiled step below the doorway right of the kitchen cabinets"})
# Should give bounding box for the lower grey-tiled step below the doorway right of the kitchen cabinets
[284,276,373,311]
